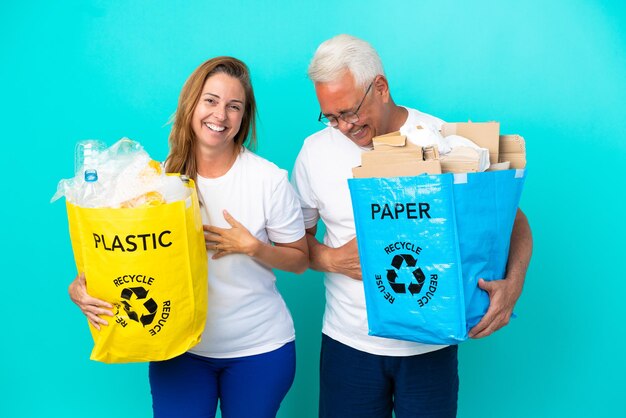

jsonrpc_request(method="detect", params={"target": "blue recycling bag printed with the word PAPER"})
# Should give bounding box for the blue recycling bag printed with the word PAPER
[348,170,525,344]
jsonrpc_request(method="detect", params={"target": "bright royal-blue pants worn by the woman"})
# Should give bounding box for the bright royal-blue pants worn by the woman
[150,341,296,418]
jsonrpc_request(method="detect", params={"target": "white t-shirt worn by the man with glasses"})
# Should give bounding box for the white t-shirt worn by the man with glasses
[292,109,445,356]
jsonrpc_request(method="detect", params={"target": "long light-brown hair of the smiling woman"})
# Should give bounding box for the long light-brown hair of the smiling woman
[165,57,256,180]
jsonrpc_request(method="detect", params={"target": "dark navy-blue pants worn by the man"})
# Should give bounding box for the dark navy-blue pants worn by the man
[320,334,459,418]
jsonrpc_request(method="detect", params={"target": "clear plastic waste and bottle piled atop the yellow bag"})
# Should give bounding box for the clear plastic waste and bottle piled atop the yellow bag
[50,138,189,208]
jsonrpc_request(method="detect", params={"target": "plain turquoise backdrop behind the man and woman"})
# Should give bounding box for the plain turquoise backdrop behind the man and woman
[0,0,626,418]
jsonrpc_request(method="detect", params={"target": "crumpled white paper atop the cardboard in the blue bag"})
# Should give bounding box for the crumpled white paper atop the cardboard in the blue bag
[400,125,489,171]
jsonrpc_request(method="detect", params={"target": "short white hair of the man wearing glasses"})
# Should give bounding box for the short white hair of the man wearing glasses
[308,34,385,88]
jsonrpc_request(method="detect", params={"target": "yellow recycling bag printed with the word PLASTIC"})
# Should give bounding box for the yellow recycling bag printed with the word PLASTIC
[67,180,208,363]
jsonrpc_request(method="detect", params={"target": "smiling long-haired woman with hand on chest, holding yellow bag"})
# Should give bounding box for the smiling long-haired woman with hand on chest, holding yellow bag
[70,57,308,418]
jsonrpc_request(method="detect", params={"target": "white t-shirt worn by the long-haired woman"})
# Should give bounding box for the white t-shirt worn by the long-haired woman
[189,150,305,358]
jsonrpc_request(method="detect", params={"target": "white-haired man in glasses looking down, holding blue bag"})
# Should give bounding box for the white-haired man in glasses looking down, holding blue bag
[293,35,532,418]
